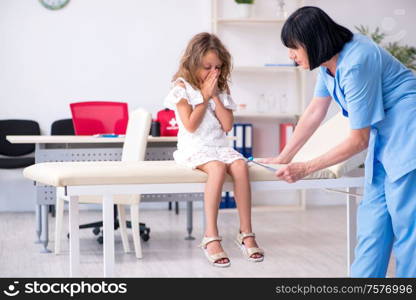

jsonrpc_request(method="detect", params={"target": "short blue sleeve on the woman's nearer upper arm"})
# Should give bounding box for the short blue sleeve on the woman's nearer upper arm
[342,62,384,129]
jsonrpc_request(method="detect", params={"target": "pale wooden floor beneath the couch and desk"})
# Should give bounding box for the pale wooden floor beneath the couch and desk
[0,206,391,277]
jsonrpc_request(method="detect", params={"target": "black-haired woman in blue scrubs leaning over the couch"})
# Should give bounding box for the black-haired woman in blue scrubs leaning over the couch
[263,6,416,277]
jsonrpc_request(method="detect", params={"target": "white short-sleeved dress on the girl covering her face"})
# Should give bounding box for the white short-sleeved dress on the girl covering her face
[164,77,245,169]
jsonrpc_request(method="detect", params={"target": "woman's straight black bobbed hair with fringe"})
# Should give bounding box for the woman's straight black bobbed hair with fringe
[281,6,353,70]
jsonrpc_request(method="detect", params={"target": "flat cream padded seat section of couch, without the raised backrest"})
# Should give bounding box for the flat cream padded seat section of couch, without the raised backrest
[23,161,335,186]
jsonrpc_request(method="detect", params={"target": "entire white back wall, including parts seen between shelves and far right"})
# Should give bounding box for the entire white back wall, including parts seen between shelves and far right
[0,0,416,210]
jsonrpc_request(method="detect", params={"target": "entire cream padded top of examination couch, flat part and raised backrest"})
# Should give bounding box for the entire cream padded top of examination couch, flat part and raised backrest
[23,114,365,186]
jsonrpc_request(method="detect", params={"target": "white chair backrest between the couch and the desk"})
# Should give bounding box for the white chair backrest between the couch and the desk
[121,108,152,161]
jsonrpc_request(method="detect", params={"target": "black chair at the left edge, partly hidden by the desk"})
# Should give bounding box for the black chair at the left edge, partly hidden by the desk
[0,119,40,156]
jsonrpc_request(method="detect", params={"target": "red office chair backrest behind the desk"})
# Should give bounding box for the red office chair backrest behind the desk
[70,101,129,135]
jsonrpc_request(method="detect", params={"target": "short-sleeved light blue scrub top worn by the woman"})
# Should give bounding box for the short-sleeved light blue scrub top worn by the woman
[314,34,416,183]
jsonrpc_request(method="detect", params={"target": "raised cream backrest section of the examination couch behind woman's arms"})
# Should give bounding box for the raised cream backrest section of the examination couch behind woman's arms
[293,113,366,177]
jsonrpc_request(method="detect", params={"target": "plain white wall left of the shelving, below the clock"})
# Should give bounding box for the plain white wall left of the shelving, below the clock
[0,0,210,129]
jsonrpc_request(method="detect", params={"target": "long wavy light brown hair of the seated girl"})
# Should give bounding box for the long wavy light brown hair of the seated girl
[173,32,231,92]
